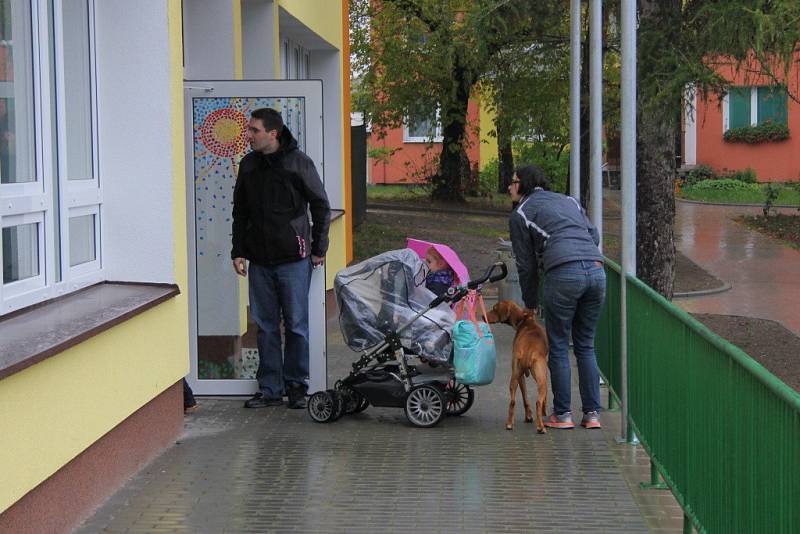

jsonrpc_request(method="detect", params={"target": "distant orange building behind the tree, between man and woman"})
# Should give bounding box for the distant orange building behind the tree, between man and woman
[368,99,482,185]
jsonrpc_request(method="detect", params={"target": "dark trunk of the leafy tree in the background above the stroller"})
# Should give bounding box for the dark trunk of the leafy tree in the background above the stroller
[431,62,472,202]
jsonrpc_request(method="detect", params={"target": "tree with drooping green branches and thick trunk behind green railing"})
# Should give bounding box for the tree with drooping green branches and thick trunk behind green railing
[636,0,800,298]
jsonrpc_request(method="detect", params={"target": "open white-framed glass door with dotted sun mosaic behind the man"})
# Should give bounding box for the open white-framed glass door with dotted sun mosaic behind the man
[184,80,326,395]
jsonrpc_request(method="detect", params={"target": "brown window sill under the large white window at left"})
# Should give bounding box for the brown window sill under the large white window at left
[0,282,180,380]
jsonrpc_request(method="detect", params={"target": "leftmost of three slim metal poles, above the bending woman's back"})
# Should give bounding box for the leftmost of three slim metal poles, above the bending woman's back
[569,0,581,200]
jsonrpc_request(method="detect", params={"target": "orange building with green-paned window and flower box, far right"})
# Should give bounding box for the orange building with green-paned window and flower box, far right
[683,54,800,182]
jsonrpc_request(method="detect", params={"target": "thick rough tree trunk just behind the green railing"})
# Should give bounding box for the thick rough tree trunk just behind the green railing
[636,0,681,299]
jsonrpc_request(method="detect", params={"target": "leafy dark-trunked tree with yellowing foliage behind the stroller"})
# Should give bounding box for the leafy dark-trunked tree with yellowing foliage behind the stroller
[351,0,562,201]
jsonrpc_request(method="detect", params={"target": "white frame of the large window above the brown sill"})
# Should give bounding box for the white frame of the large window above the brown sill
[0,0,103,316]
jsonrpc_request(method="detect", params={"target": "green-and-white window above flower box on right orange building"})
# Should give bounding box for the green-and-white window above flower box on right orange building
[723,86,788,131]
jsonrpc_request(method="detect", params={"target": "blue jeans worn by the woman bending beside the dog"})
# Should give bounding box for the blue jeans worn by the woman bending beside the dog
[544,261,606,414]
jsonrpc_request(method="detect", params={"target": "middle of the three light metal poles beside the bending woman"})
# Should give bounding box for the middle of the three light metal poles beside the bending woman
[589,0,603,246]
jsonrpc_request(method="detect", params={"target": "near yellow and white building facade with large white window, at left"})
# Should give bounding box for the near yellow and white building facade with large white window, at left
[0,0,352,532]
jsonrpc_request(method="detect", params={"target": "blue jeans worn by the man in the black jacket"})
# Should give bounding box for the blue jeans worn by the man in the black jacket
[249,258,312,398]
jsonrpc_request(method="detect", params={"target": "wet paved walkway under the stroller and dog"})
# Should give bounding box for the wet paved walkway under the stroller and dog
[79,314,682,533]
